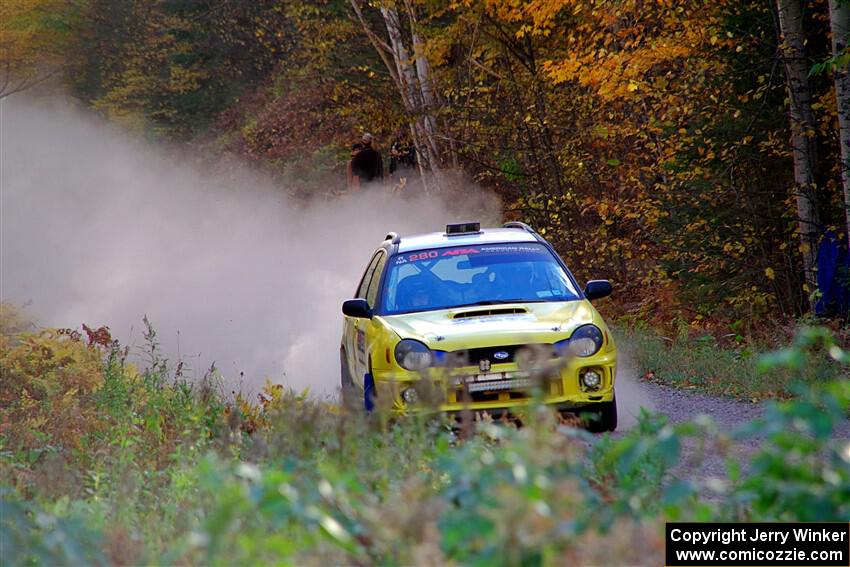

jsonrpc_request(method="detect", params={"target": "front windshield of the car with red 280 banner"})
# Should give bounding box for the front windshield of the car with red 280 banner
[381,243,579,315]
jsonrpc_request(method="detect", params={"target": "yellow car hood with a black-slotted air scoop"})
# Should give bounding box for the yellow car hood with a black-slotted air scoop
[383,300,594,351]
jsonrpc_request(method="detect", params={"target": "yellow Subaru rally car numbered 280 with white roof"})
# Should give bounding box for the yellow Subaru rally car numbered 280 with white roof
[340,222,617,431]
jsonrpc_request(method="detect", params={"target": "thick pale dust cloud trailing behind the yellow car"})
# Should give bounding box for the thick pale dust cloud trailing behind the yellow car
[0,97,499,395]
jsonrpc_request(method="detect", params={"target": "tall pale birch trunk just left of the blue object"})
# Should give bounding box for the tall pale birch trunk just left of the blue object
[777,0,820,308]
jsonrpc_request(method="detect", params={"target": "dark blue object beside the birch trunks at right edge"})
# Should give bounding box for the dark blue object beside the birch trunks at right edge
[815,231,850,316]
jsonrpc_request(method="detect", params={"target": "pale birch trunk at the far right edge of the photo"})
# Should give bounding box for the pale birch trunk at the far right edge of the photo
[829,0,850,251]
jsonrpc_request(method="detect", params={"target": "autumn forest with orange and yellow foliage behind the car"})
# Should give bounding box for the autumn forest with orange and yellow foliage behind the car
[0,0,850,335]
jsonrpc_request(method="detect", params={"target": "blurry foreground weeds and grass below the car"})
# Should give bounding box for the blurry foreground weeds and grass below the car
[0,312,850,565]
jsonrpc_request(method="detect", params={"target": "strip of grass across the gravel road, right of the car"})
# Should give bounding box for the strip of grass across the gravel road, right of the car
[614,325,850,400]
